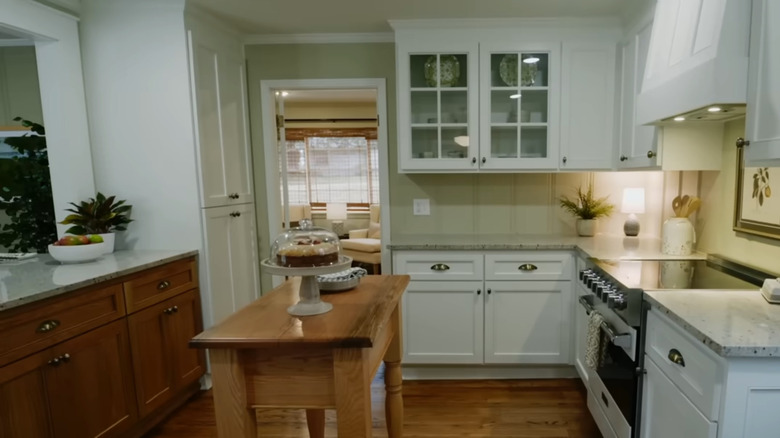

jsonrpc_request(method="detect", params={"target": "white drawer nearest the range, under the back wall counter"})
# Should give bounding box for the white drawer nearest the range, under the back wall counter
[485,251,572,281]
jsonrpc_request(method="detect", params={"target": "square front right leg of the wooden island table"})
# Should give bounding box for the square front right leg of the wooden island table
[333,348,371,438]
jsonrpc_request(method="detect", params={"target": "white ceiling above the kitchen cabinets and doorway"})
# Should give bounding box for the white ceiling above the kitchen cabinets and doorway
[190,0,642,35]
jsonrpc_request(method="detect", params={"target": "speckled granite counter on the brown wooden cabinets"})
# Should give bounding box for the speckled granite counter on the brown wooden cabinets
[0,251,198,311]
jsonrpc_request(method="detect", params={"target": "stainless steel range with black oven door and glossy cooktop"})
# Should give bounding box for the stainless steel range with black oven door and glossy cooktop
[578,255,777,438]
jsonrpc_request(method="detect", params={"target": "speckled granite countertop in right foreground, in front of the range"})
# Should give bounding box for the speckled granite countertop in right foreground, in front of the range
[645,288,780,358]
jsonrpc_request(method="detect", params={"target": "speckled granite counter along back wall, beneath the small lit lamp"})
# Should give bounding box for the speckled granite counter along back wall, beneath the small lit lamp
[387,234,706,260]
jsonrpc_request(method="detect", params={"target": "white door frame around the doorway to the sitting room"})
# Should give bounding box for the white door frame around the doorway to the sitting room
[260,78,390,287]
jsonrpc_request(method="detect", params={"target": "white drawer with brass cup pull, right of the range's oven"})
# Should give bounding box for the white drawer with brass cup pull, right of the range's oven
[645,309,725,421]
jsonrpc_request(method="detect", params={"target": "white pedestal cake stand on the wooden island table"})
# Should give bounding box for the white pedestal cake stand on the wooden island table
[260,256,352,316]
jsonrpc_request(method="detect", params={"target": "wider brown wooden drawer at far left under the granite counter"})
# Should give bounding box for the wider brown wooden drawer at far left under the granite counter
[0,284,125,366]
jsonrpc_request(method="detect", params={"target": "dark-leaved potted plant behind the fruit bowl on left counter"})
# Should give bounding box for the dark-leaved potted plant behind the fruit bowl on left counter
[60,192,133,252]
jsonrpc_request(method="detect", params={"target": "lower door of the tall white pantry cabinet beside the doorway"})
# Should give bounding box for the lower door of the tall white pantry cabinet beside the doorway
[203,204,260,324]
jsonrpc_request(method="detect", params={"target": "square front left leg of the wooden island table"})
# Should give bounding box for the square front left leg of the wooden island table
[209,349,257,438]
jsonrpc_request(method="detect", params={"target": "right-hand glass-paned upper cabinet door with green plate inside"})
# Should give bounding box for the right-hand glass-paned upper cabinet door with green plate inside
[478,45,560,170]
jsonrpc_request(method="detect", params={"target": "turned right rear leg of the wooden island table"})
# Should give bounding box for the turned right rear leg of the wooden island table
[384,306,404,438]
